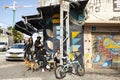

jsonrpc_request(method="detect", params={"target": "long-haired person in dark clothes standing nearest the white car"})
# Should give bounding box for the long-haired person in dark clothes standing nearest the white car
[24,37,33,59]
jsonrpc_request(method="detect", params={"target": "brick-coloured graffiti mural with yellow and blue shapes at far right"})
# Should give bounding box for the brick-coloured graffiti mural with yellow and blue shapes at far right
[93,34,120,67]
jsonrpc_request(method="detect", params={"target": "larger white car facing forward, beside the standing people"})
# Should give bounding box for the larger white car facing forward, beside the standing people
[5,43,24,60]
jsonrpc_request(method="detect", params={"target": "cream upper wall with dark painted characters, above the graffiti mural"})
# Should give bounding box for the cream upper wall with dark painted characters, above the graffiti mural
[86,0,120,21]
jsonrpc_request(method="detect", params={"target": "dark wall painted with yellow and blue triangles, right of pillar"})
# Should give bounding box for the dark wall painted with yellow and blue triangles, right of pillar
[70,23,84,59]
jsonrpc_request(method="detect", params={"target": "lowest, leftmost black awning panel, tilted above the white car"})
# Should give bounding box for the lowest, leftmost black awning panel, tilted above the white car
[15,21,36,36]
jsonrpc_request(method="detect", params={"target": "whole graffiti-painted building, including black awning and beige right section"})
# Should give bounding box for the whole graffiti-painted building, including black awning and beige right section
[16,0,120,68]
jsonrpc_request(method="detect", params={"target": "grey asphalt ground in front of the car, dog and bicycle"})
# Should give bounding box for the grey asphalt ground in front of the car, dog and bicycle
[0,52,120,80]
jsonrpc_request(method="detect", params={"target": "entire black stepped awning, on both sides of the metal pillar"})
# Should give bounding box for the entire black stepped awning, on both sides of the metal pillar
[15,0,88,35]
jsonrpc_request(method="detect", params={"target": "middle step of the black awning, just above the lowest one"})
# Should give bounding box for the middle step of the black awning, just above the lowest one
[22,14,44,30]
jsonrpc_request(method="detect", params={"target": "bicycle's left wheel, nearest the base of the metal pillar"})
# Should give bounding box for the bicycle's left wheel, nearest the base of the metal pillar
[54,65,66,79]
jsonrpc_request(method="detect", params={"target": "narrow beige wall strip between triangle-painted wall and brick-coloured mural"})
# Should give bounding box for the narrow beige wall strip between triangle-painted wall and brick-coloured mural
[84,26,92,68]
